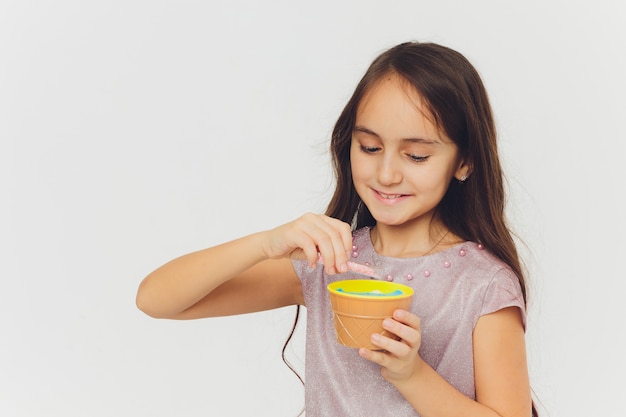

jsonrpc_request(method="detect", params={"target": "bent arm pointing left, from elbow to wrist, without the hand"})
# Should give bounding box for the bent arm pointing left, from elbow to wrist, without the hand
[137,234,302,319]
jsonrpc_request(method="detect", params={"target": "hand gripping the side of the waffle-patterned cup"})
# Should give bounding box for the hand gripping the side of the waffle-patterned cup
[359,310,422,384]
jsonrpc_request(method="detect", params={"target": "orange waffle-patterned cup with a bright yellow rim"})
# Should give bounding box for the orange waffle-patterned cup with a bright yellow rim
[327,279,413,349]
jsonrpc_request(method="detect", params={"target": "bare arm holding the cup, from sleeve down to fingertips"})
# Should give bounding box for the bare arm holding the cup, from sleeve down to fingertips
[360,307,531,417]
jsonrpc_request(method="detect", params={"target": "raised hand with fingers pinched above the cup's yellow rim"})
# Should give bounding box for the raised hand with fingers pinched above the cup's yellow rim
[263,213,352,275]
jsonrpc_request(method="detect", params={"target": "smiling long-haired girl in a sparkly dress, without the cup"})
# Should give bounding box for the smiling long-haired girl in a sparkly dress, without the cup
[137,43,534,417]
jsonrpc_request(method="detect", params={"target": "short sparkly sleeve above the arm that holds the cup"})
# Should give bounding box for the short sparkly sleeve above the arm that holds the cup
[480,268,526,329]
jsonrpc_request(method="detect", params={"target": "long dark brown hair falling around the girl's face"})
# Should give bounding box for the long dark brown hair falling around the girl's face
[326,42,526,300]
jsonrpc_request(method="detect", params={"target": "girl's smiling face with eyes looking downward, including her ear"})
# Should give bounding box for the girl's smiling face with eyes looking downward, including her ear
[350,74,468,226]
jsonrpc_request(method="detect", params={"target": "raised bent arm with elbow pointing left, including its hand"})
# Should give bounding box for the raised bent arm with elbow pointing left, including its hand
[136,214,352,319]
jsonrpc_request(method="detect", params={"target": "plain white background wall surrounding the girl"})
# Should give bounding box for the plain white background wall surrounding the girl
[0,0,626,417]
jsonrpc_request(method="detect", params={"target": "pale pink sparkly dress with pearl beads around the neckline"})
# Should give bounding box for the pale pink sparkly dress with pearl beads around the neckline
[294,228,526,417]
